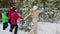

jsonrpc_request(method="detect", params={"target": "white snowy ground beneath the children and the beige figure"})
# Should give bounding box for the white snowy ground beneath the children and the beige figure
[0,22,60,34]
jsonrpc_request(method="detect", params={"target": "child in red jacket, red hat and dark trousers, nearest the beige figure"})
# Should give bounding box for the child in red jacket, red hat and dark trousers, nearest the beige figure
[10,6,23,34]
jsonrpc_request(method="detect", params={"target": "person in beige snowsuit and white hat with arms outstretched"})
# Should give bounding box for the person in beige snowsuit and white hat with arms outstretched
[24,2,44,34]
